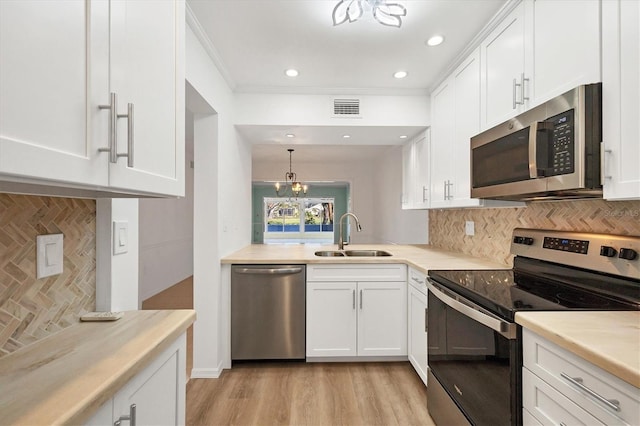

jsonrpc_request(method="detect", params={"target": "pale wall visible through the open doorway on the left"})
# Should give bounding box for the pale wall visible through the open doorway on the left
[138,131,193,304]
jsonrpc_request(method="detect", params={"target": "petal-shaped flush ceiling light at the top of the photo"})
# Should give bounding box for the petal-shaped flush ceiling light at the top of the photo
[333,0,407,28]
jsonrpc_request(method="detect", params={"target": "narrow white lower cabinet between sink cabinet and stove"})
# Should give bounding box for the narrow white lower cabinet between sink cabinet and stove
[407,268,427,385]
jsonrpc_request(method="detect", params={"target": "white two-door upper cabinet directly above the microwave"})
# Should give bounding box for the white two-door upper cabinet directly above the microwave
[480,0,601,130]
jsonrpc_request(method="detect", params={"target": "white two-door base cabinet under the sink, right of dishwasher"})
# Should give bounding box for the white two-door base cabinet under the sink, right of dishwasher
[306,265,407,358]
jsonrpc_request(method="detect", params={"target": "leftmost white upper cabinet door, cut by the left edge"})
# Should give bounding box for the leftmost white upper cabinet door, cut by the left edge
[0,0,109,186]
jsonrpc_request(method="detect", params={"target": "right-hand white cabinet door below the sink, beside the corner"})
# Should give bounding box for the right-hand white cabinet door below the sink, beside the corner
[358,281,407,356]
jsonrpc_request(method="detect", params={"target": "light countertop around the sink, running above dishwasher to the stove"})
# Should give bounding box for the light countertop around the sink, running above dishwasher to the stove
[222,244,510,273]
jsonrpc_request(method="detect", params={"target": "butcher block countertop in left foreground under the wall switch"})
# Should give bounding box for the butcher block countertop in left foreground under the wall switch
[0,310,196,425]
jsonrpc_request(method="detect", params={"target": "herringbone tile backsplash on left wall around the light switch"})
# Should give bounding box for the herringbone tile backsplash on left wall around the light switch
[0,194,96,357]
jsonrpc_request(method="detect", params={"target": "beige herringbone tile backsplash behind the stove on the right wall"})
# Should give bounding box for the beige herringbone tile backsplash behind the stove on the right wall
[429,200,640,265]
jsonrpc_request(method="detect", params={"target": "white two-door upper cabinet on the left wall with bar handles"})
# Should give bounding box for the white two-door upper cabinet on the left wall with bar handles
[0,0,185,195]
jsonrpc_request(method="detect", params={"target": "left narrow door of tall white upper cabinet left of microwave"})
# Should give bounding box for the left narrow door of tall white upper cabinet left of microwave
[429,78,455,208]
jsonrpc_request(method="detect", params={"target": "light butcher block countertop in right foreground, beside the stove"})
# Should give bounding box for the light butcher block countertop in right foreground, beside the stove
[516,311,640,388]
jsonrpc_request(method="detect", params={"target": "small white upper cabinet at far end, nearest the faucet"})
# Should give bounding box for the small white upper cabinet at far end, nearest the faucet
[402,130,430,209]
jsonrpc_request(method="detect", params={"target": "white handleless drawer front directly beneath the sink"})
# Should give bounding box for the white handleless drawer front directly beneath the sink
[307,264,407,281]
